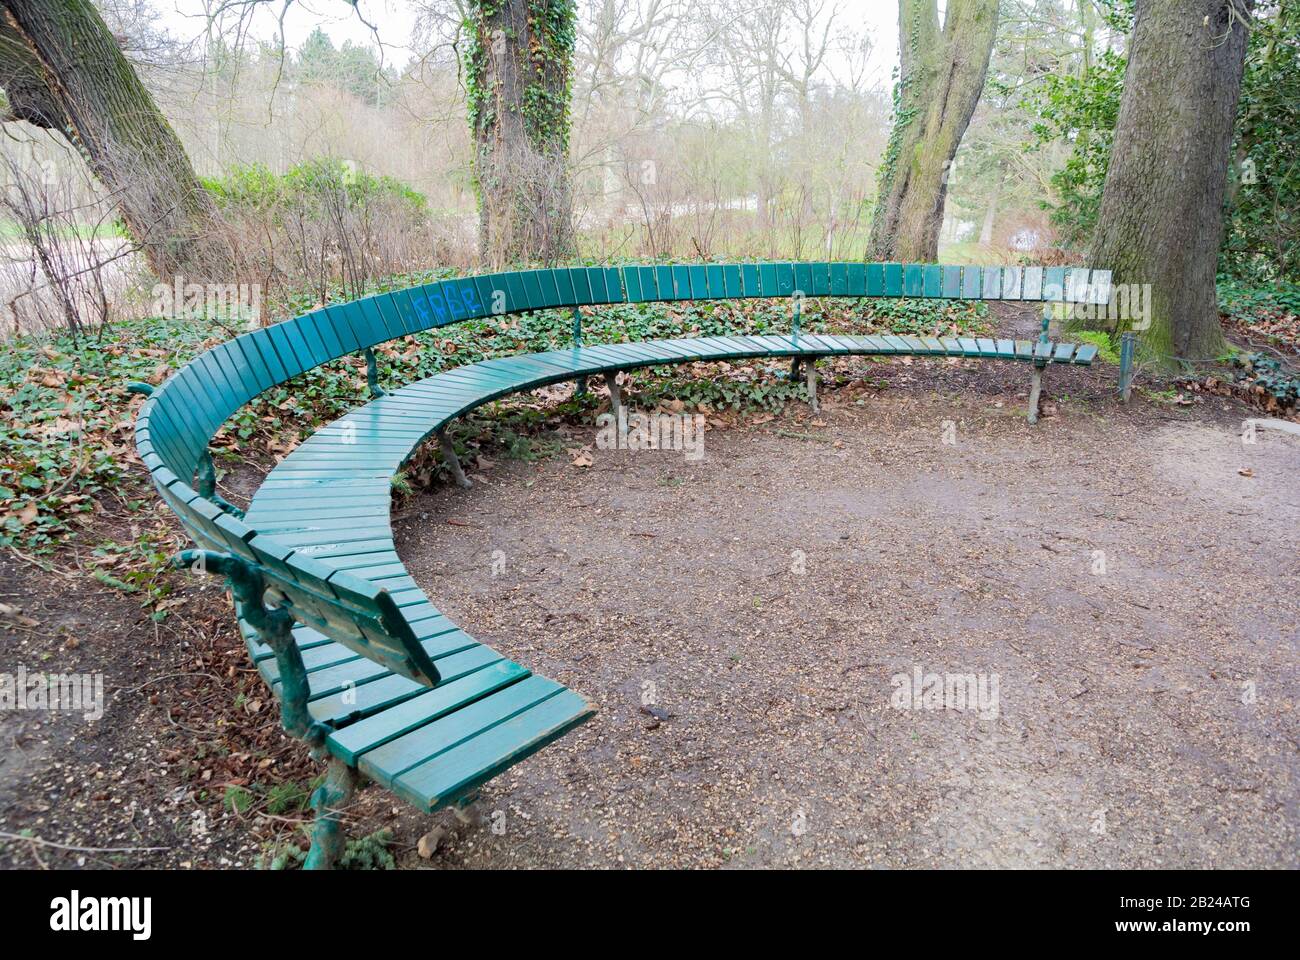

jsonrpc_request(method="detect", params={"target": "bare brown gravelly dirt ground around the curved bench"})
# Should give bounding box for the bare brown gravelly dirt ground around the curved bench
[0,308,1300,868]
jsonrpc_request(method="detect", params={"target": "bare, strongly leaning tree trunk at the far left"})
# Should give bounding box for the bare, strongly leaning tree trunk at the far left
[0,0,230,280]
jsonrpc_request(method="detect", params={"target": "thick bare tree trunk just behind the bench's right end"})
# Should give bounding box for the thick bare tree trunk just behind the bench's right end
[1088,0,1253,364]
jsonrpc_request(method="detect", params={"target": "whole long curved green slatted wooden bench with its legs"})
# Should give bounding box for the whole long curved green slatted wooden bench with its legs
[131,263,1110,868]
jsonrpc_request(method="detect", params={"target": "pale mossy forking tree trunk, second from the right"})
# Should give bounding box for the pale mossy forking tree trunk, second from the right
[867,0,997,260]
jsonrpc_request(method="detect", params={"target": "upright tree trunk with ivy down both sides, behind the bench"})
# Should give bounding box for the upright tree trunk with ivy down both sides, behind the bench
[465,0,576,268]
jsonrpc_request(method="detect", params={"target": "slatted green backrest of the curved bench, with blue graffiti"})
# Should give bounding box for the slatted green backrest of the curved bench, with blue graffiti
[135,263,1110,683]
